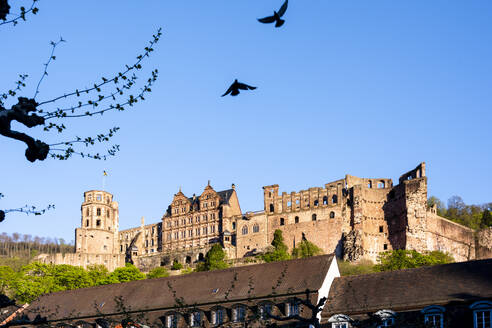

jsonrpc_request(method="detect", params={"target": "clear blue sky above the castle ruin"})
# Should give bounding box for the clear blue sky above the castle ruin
[0,0,492,241]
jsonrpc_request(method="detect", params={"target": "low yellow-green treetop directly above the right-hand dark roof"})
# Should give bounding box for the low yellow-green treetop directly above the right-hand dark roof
[375,249,454,271]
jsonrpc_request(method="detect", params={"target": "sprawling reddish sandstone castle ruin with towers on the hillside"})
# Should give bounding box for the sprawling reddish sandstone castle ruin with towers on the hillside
[39,163,492,271]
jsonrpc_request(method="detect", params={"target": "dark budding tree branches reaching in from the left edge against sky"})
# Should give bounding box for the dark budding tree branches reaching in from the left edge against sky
[0,0,161,222]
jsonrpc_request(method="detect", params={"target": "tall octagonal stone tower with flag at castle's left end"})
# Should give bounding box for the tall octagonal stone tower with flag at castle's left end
[75,190,119,254]
